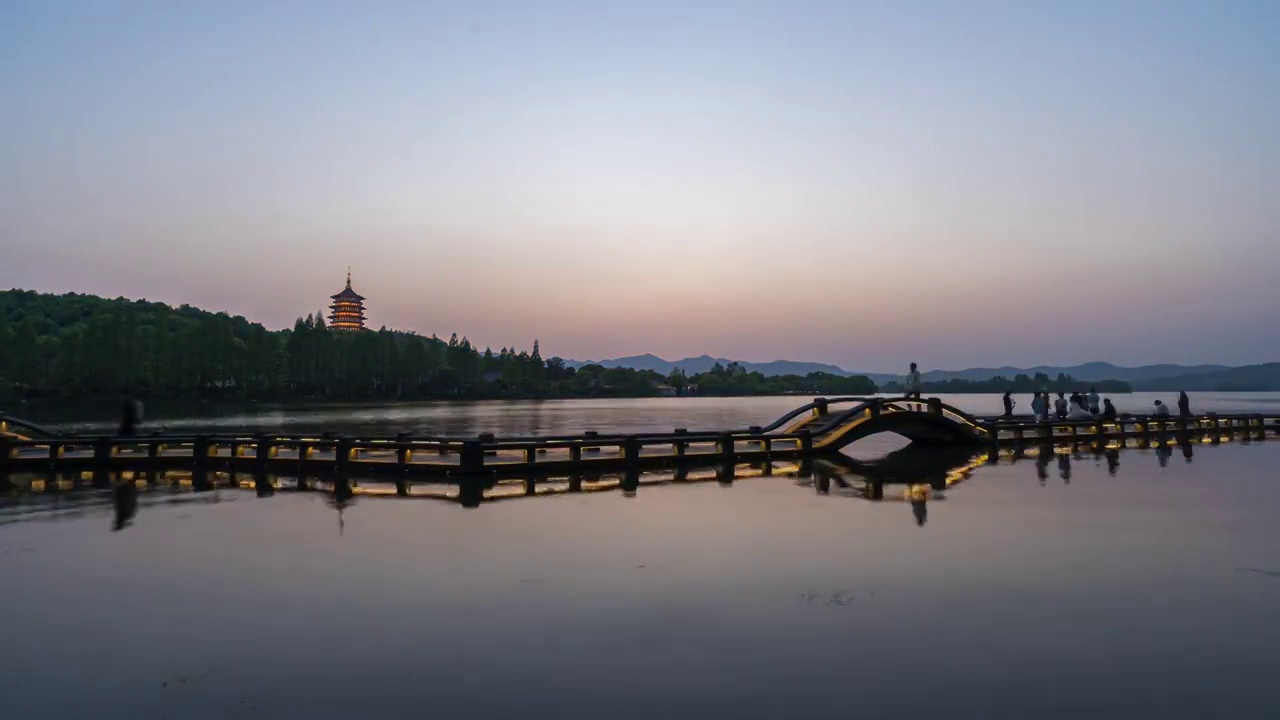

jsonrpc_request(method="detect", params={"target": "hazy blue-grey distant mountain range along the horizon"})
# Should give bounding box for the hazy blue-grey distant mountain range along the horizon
[566,354,1280,391]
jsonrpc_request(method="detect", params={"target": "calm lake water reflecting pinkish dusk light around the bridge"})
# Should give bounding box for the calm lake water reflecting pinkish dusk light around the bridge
[0,393,1280,719]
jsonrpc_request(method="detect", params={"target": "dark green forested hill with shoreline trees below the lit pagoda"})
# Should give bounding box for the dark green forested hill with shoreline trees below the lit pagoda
[0,290,876,400]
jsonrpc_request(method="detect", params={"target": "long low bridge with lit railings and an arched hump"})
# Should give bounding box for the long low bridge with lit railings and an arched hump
[0,397,1280,478]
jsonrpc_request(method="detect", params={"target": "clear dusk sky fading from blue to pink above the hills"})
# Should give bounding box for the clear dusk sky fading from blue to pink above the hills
[0,0,1280,372]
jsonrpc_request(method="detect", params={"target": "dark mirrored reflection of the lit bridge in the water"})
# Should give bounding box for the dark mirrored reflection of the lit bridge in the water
[0,425,1254,527]
